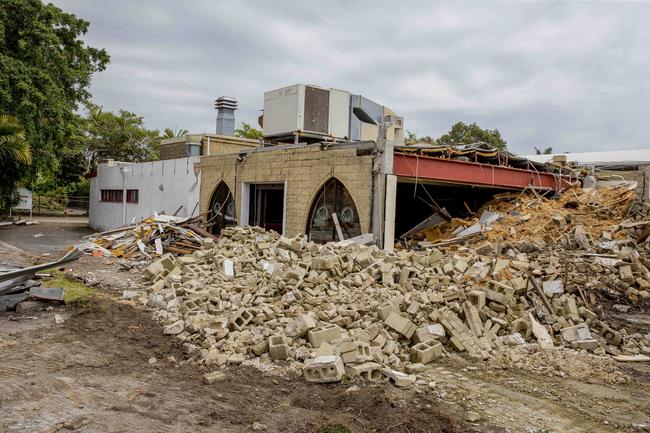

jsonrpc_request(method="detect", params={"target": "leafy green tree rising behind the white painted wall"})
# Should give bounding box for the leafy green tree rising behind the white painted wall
[83,104,160,162]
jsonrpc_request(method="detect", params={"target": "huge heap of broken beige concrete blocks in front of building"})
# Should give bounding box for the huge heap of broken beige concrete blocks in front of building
[133,186,650,386]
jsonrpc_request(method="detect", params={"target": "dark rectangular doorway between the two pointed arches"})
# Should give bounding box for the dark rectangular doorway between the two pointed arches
[249,183,284,233]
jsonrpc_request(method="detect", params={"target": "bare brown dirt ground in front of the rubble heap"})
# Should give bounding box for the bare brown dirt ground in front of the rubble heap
[0,221,650,433]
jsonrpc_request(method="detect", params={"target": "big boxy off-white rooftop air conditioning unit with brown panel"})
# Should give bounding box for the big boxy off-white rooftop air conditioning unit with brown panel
[263,84,350,138]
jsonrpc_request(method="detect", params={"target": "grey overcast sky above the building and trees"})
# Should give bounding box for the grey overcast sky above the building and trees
[54,0,650,154]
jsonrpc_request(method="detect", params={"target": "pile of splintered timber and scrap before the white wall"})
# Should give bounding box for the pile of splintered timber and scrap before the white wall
[75,214,208,259]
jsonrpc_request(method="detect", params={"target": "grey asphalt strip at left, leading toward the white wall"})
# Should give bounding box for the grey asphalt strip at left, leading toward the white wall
[0,217,93,254]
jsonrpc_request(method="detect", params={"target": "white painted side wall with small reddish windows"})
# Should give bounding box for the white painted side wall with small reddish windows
[88,157,201,230]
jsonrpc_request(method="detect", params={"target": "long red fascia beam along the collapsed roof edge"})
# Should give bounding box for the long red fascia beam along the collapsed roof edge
[393,153,571,191]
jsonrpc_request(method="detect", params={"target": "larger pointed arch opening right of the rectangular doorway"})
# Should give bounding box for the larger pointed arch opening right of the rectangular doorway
[307,178,361,243]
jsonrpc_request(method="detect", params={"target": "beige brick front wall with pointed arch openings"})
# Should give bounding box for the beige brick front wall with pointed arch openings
[201,145,372,236]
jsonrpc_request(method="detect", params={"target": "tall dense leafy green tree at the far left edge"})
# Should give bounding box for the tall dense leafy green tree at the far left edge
[0,0,109,201]
